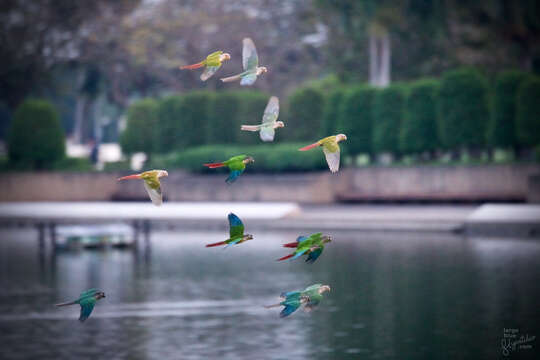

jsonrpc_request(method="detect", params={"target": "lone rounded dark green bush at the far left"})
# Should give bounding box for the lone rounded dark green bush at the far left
[8,100,65,169]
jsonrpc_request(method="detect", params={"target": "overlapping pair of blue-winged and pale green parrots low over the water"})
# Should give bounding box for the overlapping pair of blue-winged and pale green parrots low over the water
[265,284,330,318]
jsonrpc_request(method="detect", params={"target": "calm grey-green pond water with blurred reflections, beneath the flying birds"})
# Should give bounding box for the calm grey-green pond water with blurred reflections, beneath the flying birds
[0,231,540,359]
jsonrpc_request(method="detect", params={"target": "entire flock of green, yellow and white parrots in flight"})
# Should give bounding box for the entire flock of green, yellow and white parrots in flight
[56,38,347,321]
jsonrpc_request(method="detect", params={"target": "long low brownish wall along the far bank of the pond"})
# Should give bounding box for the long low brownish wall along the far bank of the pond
[0,165,540,203]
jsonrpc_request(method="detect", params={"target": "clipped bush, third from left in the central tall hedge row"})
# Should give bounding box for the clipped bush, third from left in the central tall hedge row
[175,91,212,150]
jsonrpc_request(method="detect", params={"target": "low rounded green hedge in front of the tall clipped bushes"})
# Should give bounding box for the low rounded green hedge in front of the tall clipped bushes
[152,143,327,173]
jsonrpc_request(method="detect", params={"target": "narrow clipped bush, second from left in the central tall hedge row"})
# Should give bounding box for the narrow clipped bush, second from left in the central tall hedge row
[155,95,182,153]
